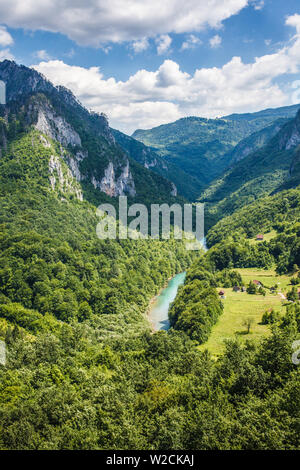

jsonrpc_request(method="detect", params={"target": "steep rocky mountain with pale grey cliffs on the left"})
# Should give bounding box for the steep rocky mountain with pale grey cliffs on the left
[0,60,180,207]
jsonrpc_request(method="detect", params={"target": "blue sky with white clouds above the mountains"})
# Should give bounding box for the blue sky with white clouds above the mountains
[0,0,300,134]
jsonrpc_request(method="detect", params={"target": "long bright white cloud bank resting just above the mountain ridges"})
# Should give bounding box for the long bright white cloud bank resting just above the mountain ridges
[35,15,300,132]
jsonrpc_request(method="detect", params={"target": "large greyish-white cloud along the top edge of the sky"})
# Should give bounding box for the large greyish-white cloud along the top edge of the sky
[0,0,250,46]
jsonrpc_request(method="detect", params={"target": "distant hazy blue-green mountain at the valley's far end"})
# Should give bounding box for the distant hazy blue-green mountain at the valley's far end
[132,105,300,198]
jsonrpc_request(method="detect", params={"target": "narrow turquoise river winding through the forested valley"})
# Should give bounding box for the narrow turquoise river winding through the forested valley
[149,272,186,331]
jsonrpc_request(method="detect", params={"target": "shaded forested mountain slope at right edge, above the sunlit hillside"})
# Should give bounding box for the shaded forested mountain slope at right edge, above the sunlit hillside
[200,111,300,226]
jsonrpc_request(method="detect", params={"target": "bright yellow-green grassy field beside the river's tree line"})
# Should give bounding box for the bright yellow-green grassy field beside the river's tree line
[199,268,291,357]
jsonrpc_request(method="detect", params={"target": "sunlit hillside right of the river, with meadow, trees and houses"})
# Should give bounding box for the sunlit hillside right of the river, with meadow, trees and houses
[170,187,300,348]
